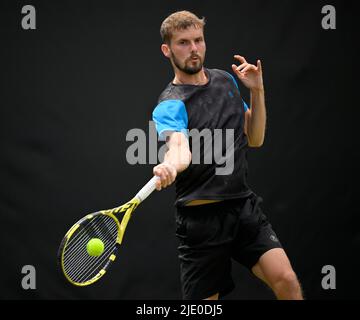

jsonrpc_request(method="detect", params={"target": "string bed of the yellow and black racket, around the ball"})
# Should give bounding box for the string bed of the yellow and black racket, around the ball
[63,214,118,283]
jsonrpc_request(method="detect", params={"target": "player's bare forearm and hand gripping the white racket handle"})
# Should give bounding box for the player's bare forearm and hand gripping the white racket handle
[153,132,191,190]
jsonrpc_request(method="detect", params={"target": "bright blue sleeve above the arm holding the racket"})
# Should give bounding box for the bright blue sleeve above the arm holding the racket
[152,100,188,141]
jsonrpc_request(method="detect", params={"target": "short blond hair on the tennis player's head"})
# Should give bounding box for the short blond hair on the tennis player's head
[160,11,205,44]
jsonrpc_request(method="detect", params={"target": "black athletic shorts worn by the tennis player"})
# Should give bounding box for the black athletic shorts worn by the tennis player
[175,194,282,300]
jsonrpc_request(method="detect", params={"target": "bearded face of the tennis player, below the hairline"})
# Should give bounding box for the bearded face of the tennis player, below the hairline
[168,27,206,74]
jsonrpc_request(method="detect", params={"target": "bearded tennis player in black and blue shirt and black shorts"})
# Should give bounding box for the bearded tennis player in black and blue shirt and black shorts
[153,11,303,300]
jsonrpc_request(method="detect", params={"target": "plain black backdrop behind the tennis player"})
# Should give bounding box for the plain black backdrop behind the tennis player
[0,0,360,299]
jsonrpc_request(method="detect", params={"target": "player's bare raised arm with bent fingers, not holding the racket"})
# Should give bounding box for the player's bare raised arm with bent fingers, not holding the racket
[232,55,266,147]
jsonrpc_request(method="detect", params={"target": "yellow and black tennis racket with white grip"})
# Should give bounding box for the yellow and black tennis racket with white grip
[58,176,159,286]
